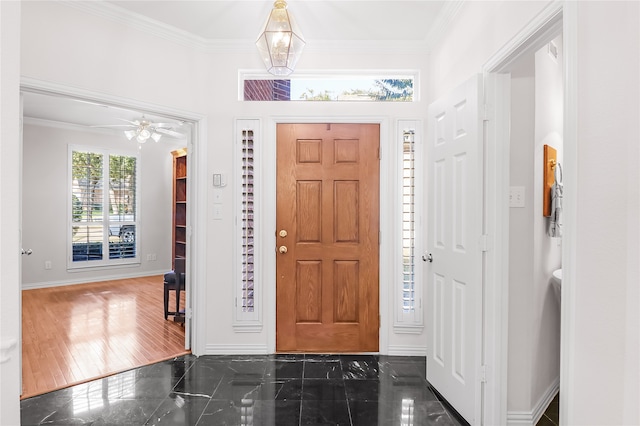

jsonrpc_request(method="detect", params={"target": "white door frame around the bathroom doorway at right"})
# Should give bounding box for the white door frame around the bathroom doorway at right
[482,1,564,424]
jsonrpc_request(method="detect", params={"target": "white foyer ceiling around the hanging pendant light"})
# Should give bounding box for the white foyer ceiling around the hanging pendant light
[106,0,451,45]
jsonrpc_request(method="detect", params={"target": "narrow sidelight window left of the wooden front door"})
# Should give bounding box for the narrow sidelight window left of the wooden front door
[234,120,261,331]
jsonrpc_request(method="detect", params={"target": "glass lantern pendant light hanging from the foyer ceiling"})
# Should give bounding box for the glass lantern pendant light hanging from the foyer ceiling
[256,0,305,75]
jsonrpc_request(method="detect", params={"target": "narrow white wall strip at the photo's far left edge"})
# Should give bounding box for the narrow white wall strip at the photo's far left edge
[0,1,21,425]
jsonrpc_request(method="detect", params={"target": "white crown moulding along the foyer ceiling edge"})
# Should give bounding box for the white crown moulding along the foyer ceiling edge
[59,0,464,54]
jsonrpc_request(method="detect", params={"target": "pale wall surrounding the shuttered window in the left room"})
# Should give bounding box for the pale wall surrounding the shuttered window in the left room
[22,120,185,289]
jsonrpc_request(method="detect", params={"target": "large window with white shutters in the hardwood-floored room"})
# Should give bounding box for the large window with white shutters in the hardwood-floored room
[67,147,140,269]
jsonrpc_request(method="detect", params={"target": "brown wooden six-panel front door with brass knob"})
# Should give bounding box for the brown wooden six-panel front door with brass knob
[276,124,380,353]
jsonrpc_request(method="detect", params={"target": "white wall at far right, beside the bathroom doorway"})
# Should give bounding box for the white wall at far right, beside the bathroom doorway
[561,1,640,425]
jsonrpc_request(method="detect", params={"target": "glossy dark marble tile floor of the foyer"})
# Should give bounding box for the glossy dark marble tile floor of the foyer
[21,354,465,426]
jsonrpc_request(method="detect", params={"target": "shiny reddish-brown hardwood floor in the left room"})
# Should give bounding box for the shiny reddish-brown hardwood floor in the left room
[22,276,189,399]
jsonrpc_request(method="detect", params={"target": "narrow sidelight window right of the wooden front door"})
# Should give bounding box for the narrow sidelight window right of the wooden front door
[395,121,423,333]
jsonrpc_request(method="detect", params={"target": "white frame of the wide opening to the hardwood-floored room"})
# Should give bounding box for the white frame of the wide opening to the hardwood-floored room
[19,77,207,355]
